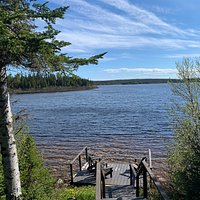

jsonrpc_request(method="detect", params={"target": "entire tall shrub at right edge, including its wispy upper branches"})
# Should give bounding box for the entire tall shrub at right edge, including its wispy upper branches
[169,59,200,199]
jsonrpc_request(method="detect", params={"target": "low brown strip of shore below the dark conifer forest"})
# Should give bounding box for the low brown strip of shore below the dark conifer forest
[10,86,97,94]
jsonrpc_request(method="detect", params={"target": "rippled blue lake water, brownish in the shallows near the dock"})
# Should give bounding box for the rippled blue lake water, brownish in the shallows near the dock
[11,84,173,173]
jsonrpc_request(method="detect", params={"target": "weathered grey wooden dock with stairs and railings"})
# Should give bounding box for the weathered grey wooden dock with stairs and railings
[69,148,169,200]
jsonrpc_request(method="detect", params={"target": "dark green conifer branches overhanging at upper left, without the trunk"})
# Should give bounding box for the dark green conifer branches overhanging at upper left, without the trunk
[0,0,105,73]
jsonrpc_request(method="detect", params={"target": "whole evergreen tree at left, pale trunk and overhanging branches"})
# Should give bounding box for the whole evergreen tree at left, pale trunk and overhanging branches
[0,0,104,200]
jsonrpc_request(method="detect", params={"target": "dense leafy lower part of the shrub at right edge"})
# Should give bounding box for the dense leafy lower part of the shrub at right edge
[169,120,200,199]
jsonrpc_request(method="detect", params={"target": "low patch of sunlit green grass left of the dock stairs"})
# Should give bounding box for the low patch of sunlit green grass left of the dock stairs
[56,186,95,200]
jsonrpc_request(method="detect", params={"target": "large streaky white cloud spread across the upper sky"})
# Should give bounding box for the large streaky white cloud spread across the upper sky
[50,0,200,52]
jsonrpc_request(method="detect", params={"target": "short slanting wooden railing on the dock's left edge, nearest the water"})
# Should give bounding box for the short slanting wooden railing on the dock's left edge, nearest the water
[69,147,88,184]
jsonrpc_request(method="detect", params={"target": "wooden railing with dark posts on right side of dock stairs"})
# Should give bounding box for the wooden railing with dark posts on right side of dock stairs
[130,157,169,200]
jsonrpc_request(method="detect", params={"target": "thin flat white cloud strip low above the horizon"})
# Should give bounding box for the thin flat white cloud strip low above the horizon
[103,68,177,75]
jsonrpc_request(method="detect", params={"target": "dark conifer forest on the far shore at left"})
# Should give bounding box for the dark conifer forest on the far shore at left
[8,72,93,90]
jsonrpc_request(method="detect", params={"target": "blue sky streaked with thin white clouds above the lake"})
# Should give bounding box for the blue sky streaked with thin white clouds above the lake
[49,0,200,80]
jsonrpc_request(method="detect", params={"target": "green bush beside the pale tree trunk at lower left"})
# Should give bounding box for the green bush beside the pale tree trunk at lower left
[0,130,54,200]
